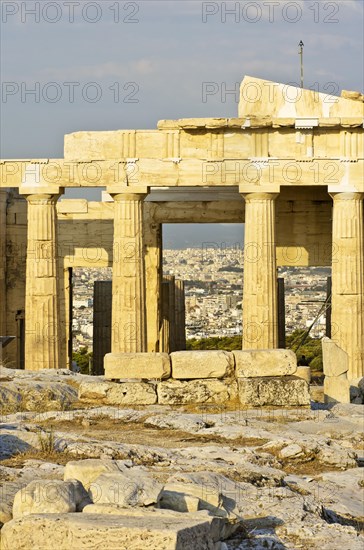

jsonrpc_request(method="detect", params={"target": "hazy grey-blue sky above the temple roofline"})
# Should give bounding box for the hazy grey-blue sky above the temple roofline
[0,0,364,246]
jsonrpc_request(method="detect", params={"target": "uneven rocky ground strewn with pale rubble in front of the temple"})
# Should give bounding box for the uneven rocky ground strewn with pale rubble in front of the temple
[0,368,364,550]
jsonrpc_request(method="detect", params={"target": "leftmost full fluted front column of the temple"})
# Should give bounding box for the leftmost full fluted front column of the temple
[25,194,61,370]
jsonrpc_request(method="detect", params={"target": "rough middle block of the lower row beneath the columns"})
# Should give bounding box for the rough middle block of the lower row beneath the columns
[157,379,237,405]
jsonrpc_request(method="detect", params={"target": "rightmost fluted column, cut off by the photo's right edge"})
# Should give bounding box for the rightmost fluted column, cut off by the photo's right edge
[331,193,364,379]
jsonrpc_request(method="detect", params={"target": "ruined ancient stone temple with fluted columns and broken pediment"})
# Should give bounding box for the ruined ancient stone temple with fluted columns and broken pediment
[0,77,364,396]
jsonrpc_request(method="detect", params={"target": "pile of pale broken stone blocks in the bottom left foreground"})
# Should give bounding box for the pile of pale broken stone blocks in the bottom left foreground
[1,459,243,550]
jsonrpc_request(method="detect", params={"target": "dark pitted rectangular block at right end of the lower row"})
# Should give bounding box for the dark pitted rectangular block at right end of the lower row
[239,376,310,407]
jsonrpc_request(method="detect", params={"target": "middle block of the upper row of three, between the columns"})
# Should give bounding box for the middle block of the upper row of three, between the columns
[171,350,234,380]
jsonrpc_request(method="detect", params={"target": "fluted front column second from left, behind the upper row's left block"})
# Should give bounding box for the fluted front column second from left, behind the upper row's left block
[111,193,147,353]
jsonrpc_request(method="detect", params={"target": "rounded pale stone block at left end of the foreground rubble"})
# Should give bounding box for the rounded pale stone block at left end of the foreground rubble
[13,479,91,519]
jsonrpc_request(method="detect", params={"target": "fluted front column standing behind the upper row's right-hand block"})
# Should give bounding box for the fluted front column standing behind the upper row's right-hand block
[243,193,278,349]
